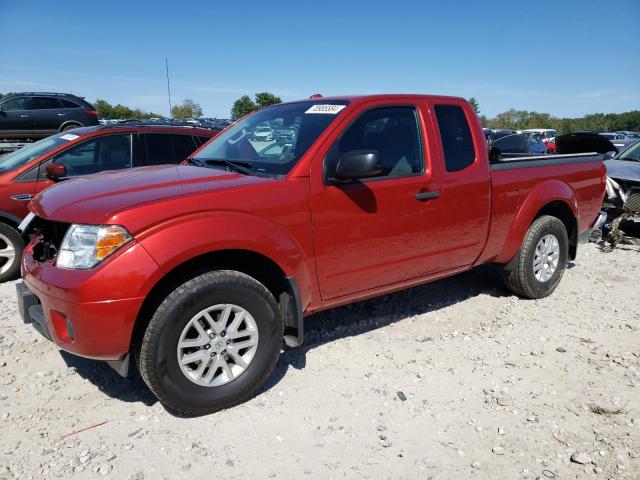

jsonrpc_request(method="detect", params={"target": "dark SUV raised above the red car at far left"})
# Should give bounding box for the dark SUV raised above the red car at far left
[0,92,98,140]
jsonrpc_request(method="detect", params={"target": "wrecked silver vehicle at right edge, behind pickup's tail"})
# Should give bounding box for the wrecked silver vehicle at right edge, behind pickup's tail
[603,142,640,248]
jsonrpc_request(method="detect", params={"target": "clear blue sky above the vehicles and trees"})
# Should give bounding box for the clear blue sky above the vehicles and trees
[0,0,640,117]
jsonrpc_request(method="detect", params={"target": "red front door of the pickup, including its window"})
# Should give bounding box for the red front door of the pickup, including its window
[311,104,442,300]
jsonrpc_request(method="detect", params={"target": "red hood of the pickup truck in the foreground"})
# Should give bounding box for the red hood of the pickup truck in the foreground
[29,165,270,224]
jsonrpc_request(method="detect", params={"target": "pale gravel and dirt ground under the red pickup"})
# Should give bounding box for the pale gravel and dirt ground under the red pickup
[0,245,640,479]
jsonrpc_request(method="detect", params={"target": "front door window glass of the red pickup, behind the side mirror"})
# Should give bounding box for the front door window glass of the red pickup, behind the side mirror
[325,107,424,178]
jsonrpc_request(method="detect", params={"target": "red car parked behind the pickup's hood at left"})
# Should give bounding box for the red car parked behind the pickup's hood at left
[0,122,219,282]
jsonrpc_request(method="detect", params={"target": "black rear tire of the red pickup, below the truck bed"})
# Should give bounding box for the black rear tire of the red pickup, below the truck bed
[503,215,569,298]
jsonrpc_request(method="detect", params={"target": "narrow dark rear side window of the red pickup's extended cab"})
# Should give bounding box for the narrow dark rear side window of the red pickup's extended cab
[434,105,476,172]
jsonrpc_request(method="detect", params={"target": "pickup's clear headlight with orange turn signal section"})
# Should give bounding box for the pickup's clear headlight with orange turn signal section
[56,223,131,269]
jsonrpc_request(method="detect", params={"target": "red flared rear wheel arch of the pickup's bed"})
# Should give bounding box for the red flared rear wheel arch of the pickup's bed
[495,179,578,263]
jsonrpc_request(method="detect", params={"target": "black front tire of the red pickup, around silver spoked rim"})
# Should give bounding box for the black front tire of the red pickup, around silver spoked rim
[138,270,284,416]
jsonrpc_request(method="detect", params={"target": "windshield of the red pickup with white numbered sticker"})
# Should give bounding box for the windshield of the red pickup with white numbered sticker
[192,100,349,175]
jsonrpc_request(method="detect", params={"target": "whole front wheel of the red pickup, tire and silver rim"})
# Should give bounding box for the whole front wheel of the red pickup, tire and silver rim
[139,270,283,415]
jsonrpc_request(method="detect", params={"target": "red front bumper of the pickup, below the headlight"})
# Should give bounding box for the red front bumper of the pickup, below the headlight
[16,238,158,362]
